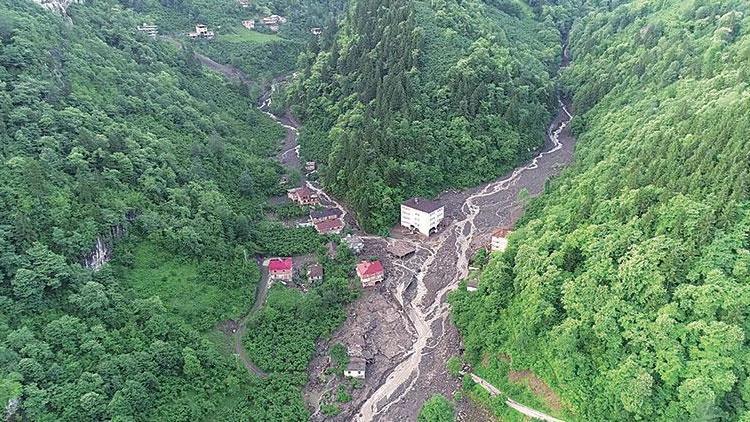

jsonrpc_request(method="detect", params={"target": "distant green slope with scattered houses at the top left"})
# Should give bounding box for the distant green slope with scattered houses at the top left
[119,0,345,82]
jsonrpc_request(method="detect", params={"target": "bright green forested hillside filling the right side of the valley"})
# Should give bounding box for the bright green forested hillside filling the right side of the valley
[452,0,750,421]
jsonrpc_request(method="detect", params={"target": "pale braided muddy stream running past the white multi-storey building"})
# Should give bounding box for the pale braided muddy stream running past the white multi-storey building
[357,101,572,421]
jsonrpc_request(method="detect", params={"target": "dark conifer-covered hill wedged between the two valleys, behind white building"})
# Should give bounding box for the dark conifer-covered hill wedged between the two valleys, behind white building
[289,0,560,230]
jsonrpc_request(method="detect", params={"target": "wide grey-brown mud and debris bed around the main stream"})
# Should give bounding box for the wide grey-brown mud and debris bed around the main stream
[305,101,575,421]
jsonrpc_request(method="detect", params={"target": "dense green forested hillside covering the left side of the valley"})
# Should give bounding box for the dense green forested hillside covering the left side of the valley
[0,0,353,421]
